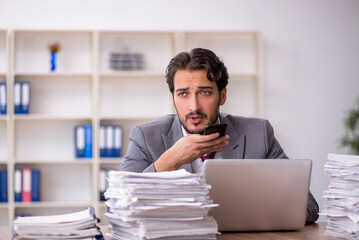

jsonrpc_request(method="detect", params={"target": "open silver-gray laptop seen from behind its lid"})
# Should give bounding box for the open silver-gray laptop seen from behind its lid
[204,159,312,232]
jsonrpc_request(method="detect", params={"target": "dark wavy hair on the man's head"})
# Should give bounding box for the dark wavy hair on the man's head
[166,48,228,93]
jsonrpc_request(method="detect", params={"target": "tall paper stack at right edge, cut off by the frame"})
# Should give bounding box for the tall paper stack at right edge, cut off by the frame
[321,154,359,239]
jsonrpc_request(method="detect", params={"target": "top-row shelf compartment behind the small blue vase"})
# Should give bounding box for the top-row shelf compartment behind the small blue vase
[13,30,93,75]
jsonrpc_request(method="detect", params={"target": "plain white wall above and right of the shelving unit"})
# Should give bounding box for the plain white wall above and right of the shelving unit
[0,0,359,220]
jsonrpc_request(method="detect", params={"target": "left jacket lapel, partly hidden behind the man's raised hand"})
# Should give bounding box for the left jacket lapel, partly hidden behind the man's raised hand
[162,116,193,173]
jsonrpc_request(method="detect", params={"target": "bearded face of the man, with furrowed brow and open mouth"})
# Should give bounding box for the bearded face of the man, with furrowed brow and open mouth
[173,70,227,134]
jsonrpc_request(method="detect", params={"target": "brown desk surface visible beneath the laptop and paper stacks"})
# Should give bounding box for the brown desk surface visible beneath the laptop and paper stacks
[0,223,341,240]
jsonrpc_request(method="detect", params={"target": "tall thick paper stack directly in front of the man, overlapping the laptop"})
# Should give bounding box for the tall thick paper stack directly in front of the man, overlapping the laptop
[105,169,218,240]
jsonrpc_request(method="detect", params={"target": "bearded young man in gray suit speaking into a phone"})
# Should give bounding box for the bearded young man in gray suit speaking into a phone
[120,48,319,223]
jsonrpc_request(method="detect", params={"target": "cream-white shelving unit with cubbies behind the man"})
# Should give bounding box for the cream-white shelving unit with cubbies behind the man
[0,30,263,225]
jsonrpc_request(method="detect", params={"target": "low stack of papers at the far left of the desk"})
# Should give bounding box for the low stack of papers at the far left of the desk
[13,208,102,239]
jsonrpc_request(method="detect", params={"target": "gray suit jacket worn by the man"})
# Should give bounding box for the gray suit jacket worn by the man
[120,113,319,223]
